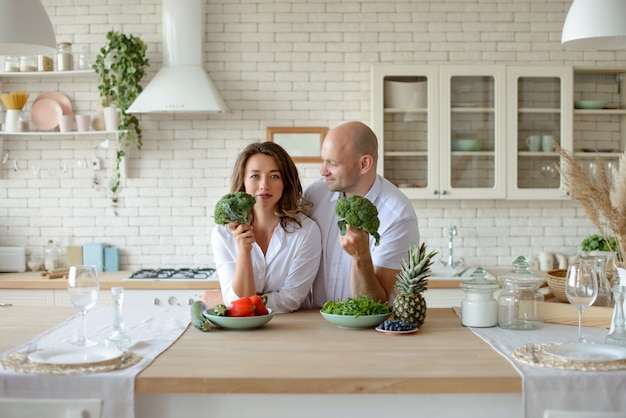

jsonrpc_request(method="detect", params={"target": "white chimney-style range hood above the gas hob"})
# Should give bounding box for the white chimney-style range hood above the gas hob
[127,0,228,113]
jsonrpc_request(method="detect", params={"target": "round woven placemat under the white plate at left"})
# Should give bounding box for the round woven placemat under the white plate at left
[0,351,142,374]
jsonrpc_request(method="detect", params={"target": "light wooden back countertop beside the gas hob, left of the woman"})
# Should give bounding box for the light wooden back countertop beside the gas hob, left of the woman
[0,271,220,290]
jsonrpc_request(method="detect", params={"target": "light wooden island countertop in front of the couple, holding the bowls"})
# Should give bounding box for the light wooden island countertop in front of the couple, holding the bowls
[135,308,522,393]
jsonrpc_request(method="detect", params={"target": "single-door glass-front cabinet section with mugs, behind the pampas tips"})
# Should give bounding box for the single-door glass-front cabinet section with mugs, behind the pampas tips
[507,67,572,199]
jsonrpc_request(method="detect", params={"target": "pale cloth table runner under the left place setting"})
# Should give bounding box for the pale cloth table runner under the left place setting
[0,306,190,418]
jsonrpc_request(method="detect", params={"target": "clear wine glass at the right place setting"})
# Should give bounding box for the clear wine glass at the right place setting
[565,258,598,343]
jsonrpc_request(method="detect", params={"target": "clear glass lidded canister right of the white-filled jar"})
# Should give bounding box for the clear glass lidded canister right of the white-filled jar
[498,256,543,330]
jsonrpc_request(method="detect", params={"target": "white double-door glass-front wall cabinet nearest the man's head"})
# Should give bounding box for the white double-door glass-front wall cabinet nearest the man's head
[372,65,506,199]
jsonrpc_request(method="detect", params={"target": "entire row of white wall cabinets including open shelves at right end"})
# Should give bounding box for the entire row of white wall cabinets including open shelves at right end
[372,65,626,200]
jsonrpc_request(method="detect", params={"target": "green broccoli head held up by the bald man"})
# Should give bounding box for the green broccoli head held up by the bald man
[335,195,380,245]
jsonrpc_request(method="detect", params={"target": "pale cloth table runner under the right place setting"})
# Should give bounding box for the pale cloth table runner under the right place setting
[454,307,626,418]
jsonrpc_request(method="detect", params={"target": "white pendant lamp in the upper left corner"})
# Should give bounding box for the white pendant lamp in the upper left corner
[0,0,57,55]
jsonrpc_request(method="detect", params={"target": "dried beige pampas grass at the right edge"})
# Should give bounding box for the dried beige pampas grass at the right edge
[555,143,626,268]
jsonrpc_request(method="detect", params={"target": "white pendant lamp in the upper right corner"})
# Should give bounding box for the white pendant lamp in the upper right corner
[561,0,626,50]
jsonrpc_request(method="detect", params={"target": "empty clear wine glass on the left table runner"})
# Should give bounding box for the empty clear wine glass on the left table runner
[67,266,100,347]
